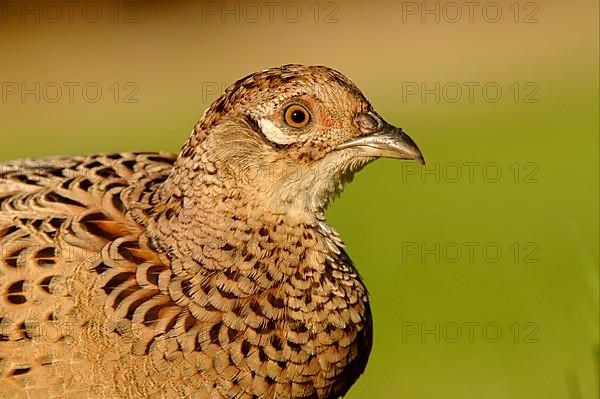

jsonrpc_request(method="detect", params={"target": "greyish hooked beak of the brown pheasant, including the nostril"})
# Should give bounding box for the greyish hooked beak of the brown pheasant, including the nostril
[336,112,425,165]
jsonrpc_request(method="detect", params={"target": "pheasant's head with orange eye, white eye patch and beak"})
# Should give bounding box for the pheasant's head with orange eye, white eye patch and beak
[166,65,424,218]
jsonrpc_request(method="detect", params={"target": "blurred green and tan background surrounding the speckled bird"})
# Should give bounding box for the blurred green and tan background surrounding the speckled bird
[0,0,599,399]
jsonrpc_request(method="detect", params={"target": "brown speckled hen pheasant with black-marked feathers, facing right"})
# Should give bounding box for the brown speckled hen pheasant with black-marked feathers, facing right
[0,65,423,399]
